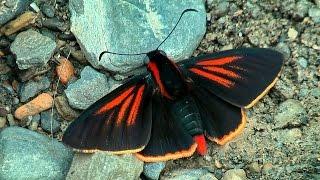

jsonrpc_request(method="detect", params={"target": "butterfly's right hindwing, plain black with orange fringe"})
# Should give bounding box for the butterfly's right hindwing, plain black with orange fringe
[192,87,246,145]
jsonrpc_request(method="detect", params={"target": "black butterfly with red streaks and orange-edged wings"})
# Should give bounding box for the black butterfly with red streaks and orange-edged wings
[62,9,284,162]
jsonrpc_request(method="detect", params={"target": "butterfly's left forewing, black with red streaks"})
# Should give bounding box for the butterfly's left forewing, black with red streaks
[62,75,153,154]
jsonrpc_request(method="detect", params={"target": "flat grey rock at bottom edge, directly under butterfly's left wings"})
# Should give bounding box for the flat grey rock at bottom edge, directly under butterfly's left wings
[66,152,143,180]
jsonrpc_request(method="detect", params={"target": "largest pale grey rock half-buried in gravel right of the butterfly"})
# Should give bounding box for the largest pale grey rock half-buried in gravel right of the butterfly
[274,99,308,129]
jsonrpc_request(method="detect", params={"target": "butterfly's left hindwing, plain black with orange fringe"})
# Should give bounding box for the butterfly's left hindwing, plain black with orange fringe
[136,95,197,162]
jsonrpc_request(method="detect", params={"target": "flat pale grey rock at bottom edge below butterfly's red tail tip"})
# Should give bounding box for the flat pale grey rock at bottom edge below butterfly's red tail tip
[162,168,209,180]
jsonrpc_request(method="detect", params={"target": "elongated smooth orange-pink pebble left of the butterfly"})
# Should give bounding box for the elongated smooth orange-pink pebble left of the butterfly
[14,93,53,120]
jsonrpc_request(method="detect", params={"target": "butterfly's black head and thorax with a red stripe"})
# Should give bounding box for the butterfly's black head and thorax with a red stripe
[147,50,188,99]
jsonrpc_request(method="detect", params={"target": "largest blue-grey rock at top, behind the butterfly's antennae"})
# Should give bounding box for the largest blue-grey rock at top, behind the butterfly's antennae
[69,0,206,72]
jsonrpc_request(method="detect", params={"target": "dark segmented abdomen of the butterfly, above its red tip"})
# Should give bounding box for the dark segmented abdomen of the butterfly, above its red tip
[170,96,203,136]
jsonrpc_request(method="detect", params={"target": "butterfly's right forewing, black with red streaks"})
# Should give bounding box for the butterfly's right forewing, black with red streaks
[180,48,283,108]
